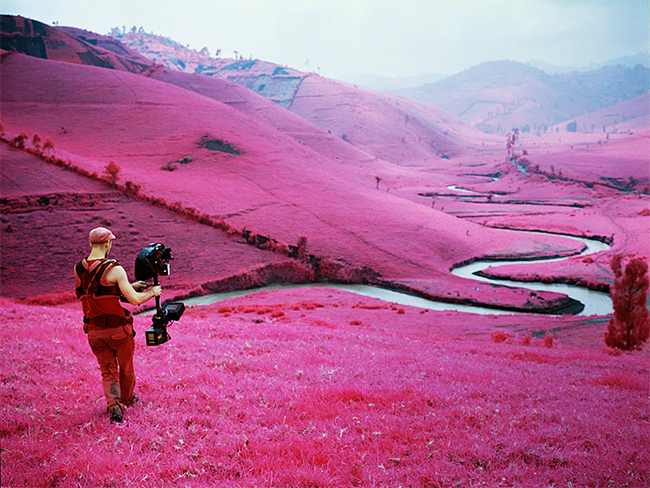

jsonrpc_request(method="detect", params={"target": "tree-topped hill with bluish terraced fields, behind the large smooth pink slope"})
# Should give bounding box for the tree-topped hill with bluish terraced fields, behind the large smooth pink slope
[106,27,495,166]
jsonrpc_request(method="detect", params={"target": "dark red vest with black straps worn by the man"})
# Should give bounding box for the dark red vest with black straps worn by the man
[75,259,129,319]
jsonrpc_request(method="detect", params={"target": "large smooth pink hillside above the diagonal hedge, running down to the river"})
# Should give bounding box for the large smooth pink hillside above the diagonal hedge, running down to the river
[2,54,575,310]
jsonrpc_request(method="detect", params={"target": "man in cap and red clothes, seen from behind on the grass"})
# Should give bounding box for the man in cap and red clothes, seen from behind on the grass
[75,227,162,422]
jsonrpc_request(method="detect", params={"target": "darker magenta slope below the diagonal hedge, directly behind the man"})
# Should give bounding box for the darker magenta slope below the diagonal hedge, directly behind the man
[0,144,294,301]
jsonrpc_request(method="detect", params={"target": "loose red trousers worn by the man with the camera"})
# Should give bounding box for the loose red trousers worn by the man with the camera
[88,324,135,409]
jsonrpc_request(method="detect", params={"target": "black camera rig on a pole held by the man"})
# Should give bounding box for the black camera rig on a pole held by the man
[135,243,185,346]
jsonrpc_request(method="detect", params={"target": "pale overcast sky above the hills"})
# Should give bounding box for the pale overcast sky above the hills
[0,0,650,78]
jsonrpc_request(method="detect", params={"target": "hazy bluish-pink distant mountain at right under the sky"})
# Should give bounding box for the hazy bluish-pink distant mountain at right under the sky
[396,61,650,133]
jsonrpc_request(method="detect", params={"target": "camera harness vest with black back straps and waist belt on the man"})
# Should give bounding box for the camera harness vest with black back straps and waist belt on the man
[75,259,133,328]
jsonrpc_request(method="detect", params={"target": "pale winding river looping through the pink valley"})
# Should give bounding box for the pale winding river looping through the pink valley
[183,231,613,315]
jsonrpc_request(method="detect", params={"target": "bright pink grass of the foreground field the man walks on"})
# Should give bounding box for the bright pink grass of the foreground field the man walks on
[0,300,650,487]
